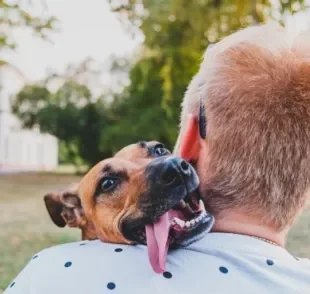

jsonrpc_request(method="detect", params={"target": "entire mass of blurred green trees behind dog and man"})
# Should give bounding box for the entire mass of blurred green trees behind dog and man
[11,0,305,164]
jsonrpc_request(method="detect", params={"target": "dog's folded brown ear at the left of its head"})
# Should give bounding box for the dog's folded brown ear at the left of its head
[44,184,86,228]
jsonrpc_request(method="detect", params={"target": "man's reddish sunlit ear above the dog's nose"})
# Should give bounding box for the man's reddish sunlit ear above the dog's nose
[180,114,201,162]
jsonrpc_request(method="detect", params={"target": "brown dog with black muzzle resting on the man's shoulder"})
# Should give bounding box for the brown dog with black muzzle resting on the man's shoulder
[44,142,213,272]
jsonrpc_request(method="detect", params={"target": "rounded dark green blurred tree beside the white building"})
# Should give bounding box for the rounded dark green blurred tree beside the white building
[12,80,105,166]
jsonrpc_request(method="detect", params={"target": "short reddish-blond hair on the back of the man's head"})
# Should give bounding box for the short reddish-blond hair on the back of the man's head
[176,25,310,231]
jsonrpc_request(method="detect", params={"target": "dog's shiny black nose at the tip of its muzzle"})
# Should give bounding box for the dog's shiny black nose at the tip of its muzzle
[161,157,191,186]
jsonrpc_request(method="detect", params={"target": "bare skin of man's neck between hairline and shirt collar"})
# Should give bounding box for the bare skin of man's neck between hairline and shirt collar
[212,212,287,247]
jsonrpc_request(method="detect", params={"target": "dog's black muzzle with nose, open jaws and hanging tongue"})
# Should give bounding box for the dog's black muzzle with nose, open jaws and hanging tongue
[121,157,214,273]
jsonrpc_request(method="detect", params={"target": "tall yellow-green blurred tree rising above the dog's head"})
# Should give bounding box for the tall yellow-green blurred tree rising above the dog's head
[103,0,306,150]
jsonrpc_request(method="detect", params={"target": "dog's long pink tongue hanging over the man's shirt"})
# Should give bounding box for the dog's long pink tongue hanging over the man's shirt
[145,212,170,273]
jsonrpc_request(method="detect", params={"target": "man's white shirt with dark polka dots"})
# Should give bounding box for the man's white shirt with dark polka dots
[4,233,310,294]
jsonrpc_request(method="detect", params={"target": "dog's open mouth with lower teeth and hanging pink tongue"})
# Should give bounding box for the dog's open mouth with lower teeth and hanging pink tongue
[126,191,214,273]
